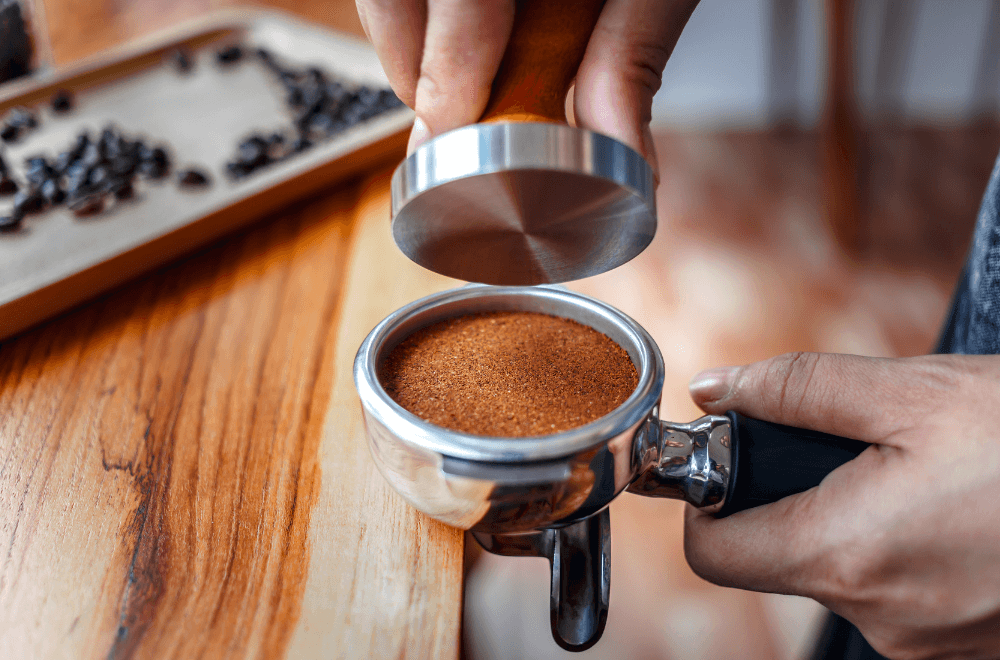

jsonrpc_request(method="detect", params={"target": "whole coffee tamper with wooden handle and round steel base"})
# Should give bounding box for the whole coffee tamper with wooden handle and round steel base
[392,0,656,285]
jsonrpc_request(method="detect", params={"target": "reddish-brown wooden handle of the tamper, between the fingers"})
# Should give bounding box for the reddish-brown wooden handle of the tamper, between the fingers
[479,0,604,124]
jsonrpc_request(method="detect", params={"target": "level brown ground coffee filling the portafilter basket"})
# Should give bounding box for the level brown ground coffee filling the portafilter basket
[379,312,639,437]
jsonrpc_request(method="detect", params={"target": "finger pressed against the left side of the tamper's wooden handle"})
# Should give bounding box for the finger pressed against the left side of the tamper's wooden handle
[409,0,514,152]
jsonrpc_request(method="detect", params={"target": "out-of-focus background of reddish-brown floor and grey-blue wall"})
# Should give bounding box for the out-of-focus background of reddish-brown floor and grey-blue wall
[9,0,1000,660]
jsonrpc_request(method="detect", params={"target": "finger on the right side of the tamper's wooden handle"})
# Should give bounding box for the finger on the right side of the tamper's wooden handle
[573,0,698,180]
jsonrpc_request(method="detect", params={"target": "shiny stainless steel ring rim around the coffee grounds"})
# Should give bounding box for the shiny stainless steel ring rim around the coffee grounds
[354,285,664,463]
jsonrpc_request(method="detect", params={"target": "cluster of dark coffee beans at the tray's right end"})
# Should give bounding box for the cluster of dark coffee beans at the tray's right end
[226,48,403,179]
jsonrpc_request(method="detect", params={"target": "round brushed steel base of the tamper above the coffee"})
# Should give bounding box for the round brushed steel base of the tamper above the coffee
[392,122,656,285]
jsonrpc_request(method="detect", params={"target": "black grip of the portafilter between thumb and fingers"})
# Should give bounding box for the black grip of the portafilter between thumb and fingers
[716,411,870,517]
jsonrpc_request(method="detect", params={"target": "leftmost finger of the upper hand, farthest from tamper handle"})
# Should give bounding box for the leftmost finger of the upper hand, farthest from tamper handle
[357,0,427,108]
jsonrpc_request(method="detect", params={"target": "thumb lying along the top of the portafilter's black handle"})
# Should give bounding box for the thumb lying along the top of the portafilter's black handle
[688,353,961,444]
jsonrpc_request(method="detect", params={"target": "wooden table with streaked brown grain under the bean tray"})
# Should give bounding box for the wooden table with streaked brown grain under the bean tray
[0,0,463,658]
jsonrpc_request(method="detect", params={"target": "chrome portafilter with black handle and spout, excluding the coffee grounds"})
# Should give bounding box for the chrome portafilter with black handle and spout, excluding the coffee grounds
[354,286,868,651]
